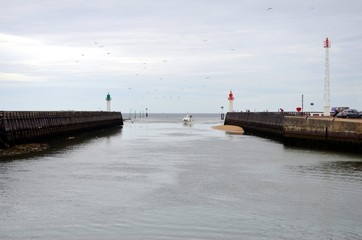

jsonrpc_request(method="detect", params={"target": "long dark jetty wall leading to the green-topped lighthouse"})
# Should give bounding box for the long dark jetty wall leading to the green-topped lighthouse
[0,111,123,148]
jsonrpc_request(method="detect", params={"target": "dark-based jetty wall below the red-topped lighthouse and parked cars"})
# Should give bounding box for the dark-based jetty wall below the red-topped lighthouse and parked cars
[224,112,362,153]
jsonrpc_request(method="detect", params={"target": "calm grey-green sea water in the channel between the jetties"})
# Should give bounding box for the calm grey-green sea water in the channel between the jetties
[0,114,362,240]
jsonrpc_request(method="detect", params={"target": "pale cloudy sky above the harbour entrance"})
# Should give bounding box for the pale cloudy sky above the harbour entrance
[0,0,362,113]
